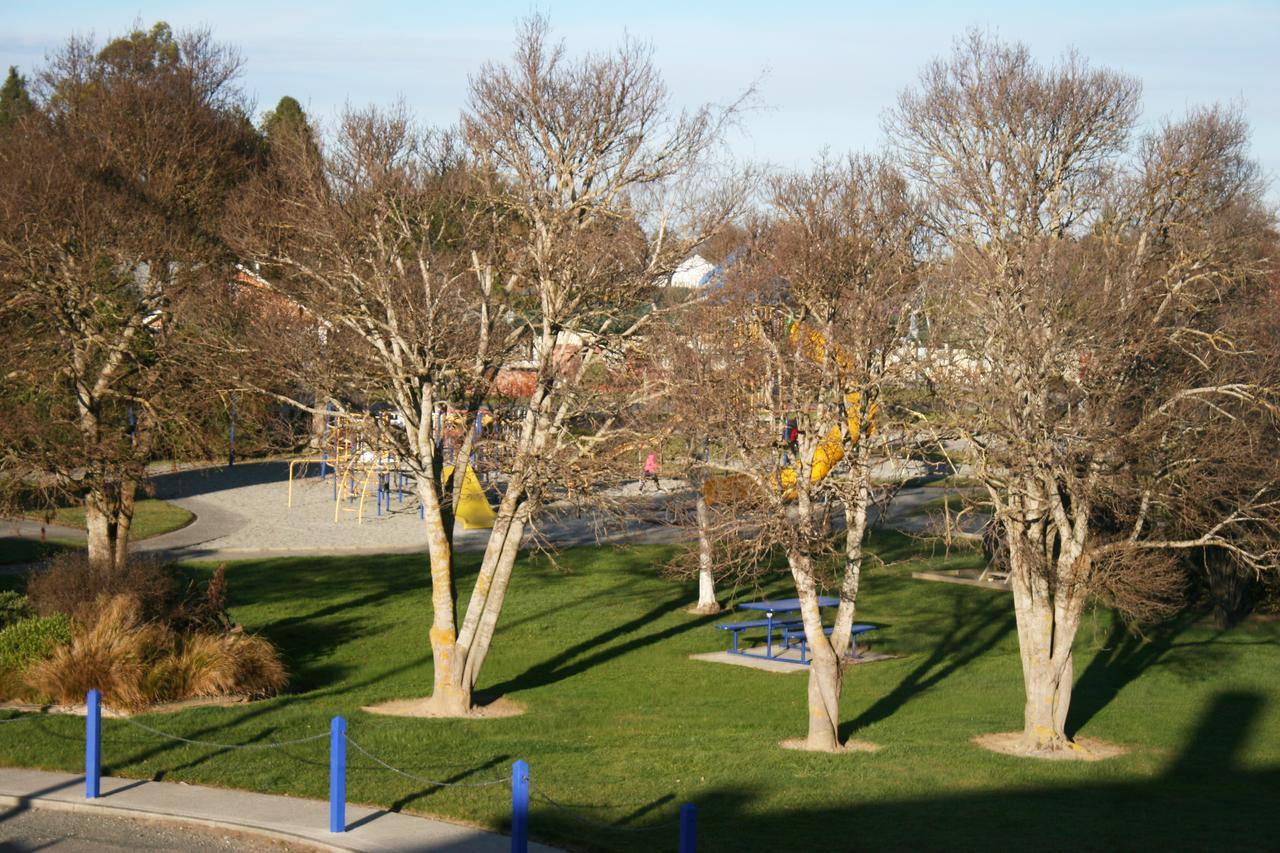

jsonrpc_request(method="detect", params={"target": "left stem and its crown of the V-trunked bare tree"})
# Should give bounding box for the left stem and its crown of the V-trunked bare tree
[232,110,520,713]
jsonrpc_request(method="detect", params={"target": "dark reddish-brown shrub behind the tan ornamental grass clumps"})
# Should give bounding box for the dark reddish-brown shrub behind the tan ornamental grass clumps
[27,551,175,624]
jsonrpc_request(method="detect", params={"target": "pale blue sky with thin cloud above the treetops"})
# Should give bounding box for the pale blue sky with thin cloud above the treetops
[0,0,1280,204]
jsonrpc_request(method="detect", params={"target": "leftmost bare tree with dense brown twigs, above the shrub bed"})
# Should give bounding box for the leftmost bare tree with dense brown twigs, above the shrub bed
[0,24,257,566]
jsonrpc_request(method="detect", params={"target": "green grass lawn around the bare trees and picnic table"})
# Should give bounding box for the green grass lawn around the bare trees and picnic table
[0,535,1280,850]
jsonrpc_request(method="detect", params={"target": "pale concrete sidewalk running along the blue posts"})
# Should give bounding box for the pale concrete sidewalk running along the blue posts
[0,767,556,853]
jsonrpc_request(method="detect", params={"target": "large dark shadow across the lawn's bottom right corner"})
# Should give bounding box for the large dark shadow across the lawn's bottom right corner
[586,692,1280,853]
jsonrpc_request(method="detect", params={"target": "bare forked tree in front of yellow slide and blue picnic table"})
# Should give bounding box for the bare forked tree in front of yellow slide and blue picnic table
[665,156,920,751]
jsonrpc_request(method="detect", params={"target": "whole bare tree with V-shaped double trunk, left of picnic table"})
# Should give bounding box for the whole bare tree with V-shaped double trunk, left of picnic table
[227,19,736,715]
